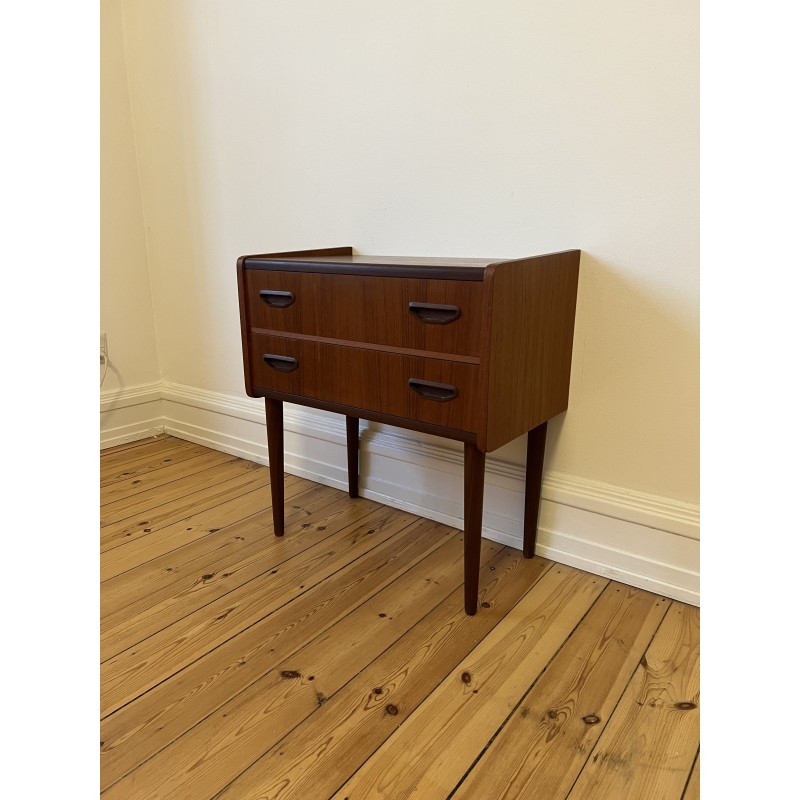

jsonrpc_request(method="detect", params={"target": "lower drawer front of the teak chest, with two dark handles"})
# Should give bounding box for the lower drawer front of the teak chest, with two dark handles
[250,334,484,431]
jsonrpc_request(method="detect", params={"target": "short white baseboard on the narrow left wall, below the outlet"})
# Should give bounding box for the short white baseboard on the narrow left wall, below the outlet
[100,381,164,450]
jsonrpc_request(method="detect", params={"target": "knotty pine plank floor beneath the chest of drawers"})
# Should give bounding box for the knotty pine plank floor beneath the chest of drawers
[100,437,700,800]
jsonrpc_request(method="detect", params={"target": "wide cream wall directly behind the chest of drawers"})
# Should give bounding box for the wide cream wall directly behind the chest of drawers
[118,0,699,502]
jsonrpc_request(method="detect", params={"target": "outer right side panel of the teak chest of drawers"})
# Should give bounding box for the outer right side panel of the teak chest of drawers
[487,250,580,451]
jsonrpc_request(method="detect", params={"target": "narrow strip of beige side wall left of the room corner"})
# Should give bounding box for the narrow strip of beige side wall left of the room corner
[100,0,159,392]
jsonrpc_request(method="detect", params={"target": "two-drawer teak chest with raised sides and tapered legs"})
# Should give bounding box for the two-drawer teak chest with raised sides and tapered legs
[237,247,580,614]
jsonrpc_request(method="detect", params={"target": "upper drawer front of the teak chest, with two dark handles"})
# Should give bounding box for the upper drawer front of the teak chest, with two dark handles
[245,270,485,356]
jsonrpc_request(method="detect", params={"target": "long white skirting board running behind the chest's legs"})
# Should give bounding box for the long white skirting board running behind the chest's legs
[161,381,700,605]
